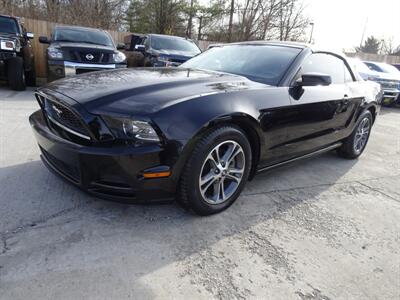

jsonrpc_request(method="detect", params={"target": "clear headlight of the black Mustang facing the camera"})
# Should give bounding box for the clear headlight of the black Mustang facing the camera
[103,117,160,142]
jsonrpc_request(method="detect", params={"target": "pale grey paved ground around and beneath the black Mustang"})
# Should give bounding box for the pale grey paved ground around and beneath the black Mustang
[0,88,400,300]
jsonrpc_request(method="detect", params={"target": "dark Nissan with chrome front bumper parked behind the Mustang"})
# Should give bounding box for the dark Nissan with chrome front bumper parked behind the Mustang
[39,26,126,81]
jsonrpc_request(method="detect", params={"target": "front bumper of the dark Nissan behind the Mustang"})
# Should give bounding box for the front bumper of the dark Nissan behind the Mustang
[47,60,127,81]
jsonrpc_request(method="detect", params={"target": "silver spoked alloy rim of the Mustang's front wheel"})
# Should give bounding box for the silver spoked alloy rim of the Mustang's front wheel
[199,140,246,204]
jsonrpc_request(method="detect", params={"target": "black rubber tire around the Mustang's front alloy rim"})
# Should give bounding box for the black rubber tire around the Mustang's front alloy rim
[186,126,252,215]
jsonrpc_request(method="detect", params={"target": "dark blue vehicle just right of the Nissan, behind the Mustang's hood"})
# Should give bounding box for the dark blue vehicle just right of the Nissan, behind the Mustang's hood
[129,34,201,67]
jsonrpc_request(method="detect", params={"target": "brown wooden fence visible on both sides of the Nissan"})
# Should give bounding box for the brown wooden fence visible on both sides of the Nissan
[24,18,130,78]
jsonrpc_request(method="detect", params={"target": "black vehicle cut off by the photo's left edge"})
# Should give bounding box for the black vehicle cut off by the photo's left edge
[0,15,36,91]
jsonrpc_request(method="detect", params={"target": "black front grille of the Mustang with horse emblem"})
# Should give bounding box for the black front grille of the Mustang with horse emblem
[37,95,90,140]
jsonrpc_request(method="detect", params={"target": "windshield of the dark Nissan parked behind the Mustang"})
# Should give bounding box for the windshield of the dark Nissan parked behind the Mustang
[54,28,114,47]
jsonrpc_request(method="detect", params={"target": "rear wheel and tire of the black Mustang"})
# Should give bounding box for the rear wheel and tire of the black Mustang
[337,110,373,159]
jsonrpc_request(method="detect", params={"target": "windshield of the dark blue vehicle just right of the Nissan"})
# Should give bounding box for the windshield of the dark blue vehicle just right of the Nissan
[151,36,201,55]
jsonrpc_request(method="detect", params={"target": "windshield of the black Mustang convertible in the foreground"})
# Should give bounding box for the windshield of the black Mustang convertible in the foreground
[181,45,301,85]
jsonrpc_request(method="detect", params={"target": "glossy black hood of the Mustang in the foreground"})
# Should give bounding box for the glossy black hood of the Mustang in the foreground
[41,68,268,115]
